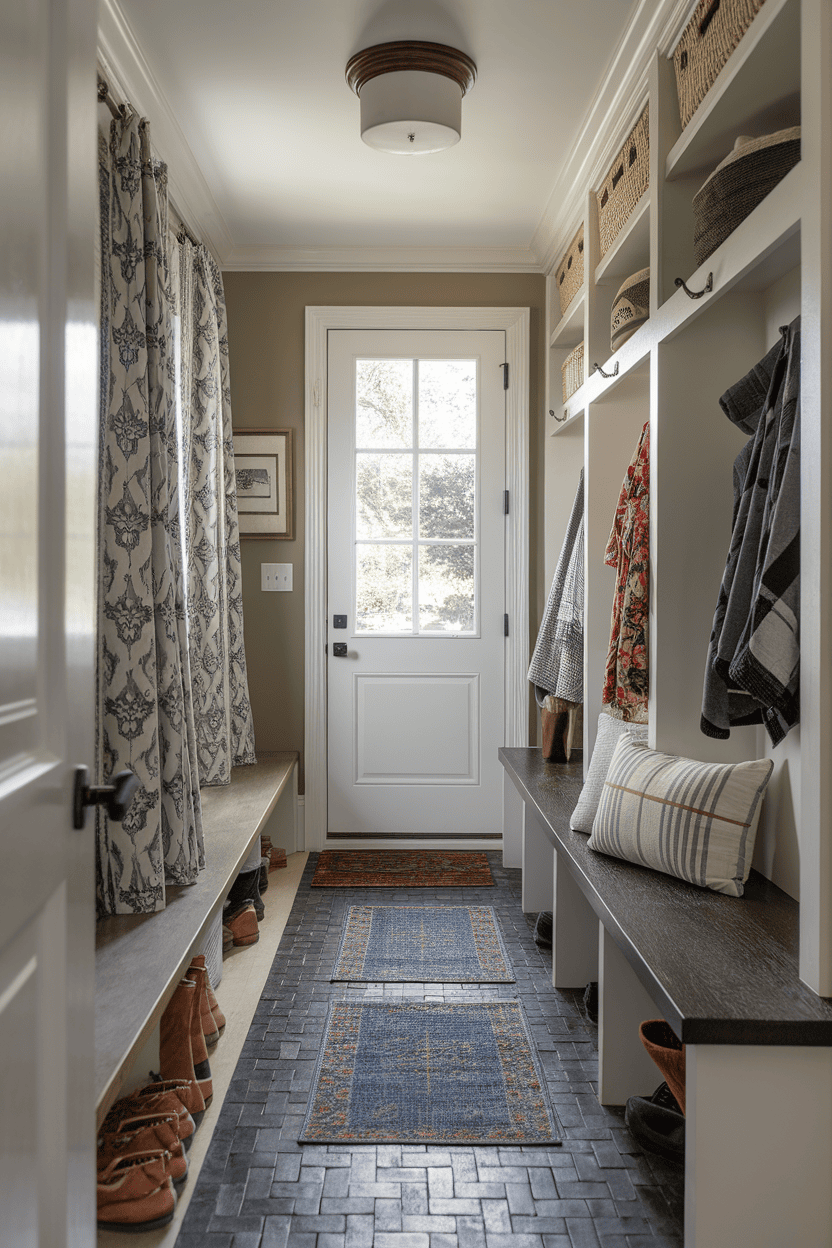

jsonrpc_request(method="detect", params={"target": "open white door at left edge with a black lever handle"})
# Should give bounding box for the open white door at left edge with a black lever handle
[0,0,97,1248]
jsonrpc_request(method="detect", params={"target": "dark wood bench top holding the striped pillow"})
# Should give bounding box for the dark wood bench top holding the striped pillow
[499,748,832,1046]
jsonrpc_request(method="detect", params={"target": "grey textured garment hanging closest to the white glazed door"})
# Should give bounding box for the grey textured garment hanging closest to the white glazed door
[529,469,584,706]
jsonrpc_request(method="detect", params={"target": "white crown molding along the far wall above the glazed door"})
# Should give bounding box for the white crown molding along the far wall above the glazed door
[222,246,541,273]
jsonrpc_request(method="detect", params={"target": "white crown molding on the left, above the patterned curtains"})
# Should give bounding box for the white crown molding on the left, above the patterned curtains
[99,0,233,262]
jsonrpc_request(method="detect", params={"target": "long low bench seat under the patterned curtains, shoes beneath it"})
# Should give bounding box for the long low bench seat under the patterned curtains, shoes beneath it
[95,751,298,1126]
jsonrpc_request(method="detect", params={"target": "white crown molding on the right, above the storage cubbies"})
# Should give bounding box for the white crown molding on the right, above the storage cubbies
[531,0,696,273]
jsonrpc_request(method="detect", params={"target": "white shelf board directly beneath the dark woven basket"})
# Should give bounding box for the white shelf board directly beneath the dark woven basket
[658,163,803,342]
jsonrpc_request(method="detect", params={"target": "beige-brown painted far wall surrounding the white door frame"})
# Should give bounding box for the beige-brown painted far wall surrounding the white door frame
[223,272,545,791]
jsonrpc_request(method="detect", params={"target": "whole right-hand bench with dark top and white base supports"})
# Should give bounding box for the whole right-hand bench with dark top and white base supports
[500,749,832,1248]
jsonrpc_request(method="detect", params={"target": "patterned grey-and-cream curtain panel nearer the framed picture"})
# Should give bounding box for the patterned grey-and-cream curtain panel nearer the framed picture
[178,238,257,785]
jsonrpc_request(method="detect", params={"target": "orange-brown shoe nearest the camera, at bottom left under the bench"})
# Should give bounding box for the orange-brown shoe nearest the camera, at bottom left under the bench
[97,1148,176,1232]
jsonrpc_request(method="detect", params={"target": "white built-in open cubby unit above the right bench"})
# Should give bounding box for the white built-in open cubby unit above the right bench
[545,0,832,996]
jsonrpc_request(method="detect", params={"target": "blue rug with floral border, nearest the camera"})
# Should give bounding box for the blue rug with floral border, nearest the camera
[298,1001,560,1144]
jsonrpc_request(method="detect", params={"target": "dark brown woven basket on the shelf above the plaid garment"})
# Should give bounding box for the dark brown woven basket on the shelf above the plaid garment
[694,126,801,267]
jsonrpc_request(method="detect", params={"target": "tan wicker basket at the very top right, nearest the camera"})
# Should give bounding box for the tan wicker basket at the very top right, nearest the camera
[674,0,763,130]
